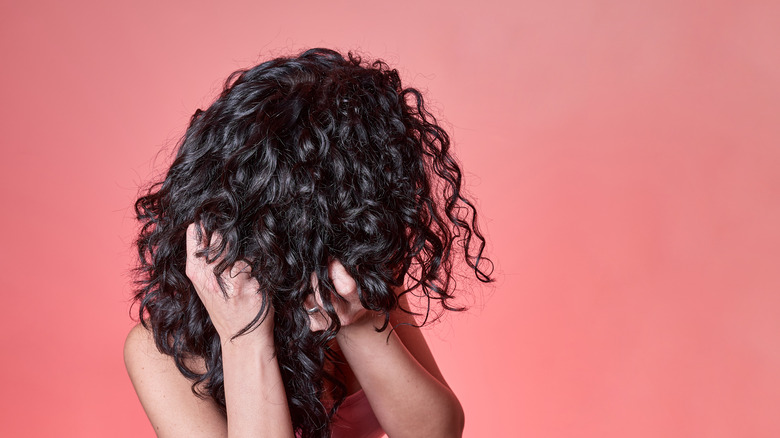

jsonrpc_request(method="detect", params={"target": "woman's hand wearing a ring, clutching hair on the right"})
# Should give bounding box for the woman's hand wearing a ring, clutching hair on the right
[304,260,374,331]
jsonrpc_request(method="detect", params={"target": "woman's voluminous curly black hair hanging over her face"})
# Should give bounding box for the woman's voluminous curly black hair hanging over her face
[134,49,492,438]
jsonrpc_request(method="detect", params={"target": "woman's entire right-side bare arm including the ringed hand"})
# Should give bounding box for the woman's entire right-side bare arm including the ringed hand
[307,261,464,438]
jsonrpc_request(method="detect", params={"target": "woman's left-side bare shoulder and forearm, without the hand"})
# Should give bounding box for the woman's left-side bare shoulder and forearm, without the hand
[125,324,292,438]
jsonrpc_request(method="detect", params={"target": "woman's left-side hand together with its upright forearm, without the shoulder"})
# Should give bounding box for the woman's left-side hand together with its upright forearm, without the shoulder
[186,224,294,437]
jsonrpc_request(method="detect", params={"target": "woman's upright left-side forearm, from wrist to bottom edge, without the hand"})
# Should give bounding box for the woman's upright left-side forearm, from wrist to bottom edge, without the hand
[222,334,293,438]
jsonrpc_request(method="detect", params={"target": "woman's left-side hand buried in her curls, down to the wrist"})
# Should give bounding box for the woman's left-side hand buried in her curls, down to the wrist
[186,224,274,346]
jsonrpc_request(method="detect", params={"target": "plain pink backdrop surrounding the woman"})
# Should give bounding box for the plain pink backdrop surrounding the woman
[0,0,780,437]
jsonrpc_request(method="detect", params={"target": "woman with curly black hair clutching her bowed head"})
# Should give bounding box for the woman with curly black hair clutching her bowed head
[125,49,492,438]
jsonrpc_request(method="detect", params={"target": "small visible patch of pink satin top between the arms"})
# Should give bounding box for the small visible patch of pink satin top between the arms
[331,389,386,438]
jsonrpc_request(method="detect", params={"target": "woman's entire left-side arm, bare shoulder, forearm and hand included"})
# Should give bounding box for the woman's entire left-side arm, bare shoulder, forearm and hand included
[125,225,293,438]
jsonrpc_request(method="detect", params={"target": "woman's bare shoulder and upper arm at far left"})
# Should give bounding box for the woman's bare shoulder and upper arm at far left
[124,324,227,437]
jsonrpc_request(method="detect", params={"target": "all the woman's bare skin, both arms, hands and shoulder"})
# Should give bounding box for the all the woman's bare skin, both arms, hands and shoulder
[124,225,464,438]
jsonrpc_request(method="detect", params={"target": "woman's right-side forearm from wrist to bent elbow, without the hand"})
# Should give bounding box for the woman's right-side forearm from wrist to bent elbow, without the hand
[336,314,463,438]
